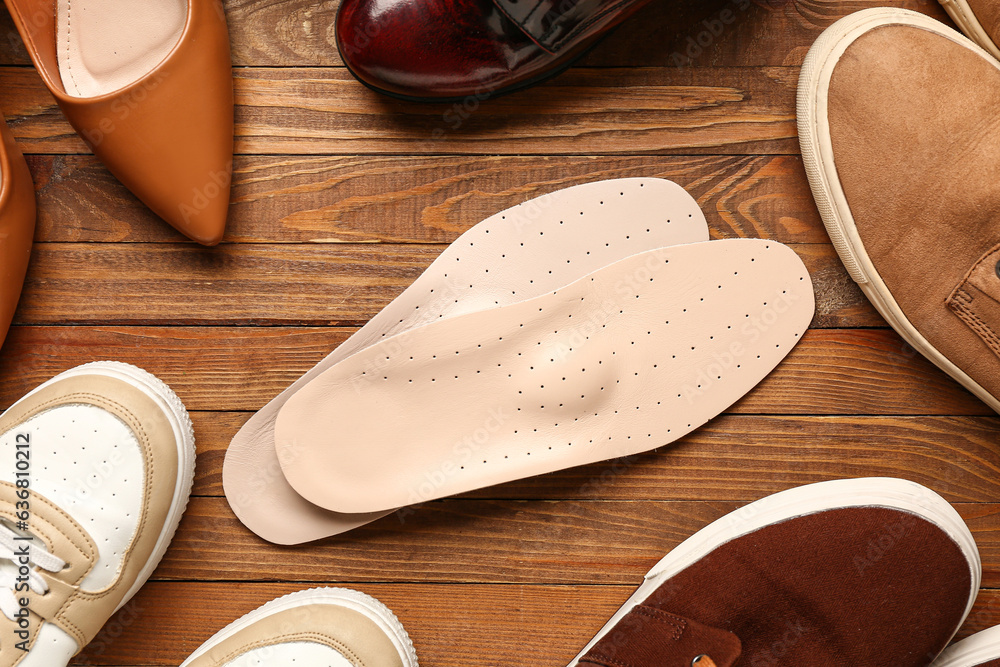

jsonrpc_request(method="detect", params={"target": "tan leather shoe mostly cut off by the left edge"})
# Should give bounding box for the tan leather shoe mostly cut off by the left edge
[0,117,35,354]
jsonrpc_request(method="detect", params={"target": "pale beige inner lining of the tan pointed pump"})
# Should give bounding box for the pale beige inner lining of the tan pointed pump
[56,0,187,97]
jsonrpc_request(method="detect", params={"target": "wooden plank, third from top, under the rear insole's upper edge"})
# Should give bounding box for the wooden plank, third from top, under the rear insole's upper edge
[28,155,829,243]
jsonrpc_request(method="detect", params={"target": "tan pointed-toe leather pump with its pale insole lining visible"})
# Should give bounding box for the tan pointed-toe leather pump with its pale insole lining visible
[5,0,233,245]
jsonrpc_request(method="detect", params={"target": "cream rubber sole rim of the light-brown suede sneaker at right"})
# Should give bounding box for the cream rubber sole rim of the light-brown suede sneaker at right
[797,9,1000,412]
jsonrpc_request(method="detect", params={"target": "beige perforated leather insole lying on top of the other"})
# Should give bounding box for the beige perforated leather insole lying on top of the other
[275,239,814,513]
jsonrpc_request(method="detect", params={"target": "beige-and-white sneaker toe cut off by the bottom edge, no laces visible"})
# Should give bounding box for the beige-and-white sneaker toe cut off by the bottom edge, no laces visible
[181,588,417,667]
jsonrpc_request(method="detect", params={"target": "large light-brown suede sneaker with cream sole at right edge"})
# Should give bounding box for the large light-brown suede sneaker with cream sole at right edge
[798,9,1000,411]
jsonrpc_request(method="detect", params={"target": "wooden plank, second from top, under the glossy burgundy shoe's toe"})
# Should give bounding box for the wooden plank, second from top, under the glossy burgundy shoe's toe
[0,67,799,155]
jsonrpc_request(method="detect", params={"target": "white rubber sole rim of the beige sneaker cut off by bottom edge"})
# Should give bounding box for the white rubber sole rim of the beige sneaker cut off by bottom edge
[181,588,417,667]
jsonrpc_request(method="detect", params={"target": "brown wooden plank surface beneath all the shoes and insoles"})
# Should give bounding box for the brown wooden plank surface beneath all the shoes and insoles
[0,0,1000,667]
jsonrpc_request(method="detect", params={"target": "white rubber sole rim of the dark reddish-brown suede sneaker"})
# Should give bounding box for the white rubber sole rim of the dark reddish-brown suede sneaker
[569,477,982,667]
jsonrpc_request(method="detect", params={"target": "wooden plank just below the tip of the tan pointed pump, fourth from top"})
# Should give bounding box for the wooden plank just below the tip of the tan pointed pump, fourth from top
[15,243,884,327]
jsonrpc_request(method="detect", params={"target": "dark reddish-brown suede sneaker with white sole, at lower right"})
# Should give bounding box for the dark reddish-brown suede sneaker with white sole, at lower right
[570,478,980,667]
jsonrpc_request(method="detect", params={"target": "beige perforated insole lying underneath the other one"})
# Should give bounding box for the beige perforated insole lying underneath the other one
[223,178,708,544]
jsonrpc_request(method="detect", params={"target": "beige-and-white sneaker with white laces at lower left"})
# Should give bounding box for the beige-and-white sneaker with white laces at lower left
[0,362,195,667]
